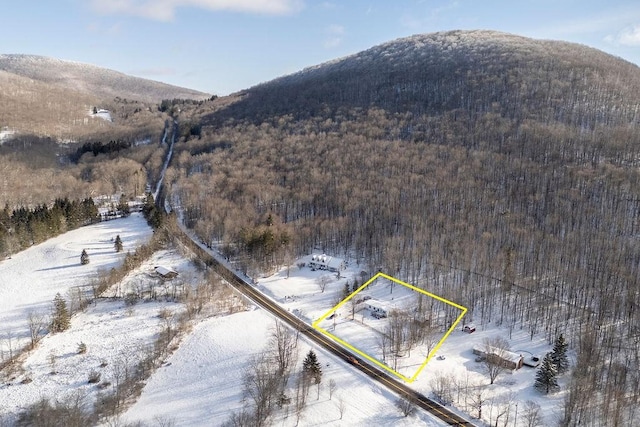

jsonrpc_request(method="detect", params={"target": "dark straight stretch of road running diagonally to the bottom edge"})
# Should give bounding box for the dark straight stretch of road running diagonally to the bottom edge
[170,227,474,426]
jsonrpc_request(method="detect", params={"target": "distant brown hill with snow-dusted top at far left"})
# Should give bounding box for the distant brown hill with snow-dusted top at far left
[0,55,210,142]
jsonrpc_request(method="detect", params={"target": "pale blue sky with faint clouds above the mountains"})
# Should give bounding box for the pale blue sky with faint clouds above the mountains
[0,0,640,95]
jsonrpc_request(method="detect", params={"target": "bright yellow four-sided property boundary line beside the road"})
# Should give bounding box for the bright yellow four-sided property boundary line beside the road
[311,273,467,383]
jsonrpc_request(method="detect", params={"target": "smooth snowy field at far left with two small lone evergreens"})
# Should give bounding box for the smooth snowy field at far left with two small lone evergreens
[0,214,153,353]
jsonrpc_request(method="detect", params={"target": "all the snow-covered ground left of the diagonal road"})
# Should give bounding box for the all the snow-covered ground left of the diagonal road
[0,214,450,426]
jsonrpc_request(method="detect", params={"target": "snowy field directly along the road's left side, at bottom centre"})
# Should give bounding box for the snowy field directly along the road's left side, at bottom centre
[122,310,442,426]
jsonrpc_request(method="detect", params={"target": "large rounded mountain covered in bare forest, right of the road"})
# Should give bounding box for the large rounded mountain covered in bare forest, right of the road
[169,31,640,425]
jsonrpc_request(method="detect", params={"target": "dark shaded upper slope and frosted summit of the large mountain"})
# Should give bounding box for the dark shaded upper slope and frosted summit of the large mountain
[209,30,640,134]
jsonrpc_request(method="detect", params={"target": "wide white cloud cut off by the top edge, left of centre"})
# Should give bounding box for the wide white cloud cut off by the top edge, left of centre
[91,0,301,21]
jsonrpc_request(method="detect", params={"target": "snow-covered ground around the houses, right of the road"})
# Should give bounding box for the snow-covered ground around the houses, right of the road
[252,257,568,426]
